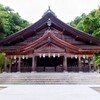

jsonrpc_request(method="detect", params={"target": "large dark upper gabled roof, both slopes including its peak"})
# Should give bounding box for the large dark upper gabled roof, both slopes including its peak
[0,9,100,46]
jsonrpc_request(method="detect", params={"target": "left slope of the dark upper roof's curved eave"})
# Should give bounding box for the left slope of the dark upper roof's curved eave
[0,15,49,45]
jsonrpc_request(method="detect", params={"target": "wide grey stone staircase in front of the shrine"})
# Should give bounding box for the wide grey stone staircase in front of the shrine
[0,72,100,85]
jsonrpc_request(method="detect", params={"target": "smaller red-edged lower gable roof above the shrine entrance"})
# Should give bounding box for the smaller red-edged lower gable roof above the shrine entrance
[0,33,81,54]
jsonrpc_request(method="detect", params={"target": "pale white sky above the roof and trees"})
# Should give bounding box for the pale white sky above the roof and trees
[0,0,100,23]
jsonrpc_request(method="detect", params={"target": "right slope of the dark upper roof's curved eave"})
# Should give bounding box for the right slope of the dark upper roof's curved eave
[51,13,100,45]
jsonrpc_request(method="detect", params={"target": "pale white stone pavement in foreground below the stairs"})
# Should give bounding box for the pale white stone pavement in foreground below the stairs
[0,85,100,100]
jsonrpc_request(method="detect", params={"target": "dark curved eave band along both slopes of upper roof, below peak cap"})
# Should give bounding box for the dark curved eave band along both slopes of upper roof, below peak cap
[0,12,100,45]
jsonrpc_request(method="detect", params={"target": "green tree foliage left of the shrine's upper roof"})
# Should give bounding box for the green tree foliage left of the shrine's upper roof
[0,4,29,38]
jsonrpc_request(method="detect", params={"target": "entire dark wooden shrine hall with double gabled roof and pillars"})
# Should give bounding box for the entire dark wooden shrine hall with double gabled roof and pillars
[0,8,100,72]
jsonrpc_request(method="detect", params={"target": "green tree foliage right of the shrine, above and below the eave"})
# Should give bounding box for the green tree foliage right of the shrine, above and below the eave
[69,7,100,64]
